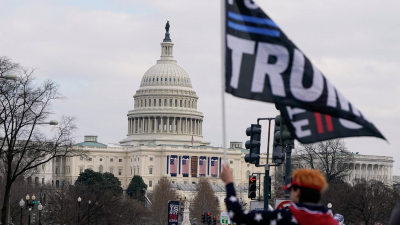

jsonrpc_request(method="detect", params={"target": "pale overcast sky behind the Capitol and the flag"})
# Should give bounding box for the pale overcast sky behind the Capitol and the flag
[0,0,400,175]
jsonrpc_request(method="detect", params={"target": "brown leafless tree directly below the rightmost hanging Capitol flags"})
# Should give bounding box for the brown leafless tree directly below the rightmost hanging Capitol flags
[190,179,220,221]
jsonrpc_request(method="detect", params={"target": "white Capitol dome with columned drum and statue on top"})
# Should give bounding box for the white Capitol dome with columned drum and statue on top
[120,25,210,146]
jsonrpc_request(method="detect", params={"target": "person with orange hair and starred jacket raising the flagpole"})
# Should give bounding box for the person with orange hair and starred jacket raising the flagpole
[220,165,338,225]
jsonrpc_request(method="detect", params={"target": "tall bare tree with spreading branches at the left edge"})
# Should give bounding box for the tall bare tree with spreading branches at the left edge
[0,57,78,223]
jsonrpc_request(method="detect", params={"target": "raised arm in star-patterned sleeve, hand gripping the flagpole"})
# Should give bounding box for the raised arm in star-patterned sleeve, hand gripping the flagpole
[220,165,286,225]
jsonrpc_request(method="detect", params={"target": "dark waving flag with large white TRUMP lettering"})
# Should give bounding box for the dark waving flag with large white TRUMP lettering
[223,0,385,143]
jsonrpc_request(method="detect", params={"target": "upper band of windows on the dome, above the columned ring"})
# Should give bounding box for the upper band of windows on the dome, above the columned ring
[135,99,197,109]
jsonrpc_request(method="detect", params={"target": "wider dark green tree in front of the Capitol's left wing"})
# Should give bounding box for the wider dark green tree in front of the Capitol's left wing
[75,169,123,196]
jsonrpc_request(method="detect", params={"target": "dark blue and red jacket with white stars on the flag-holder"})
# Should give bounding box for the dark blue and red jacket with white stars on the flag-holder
[226,183,338,225]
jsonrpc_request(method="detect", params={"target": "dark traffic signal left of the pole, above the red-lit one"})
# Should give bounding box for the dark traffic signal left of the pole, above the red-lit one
[244,124,261,165]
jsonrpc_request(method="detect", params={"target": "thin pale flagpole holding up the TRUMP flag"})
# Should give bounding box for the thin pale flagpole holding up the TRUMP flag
[221,0,228,165]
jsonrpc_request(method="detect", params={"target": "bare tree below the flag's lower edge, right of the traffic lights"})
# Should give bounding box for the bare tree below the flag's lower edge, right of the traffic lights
[292,139,354,183]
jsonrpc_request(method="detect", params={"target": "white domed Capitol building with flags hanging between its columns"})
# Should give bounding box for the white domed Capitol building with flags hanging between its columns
[32,25,393,198]
